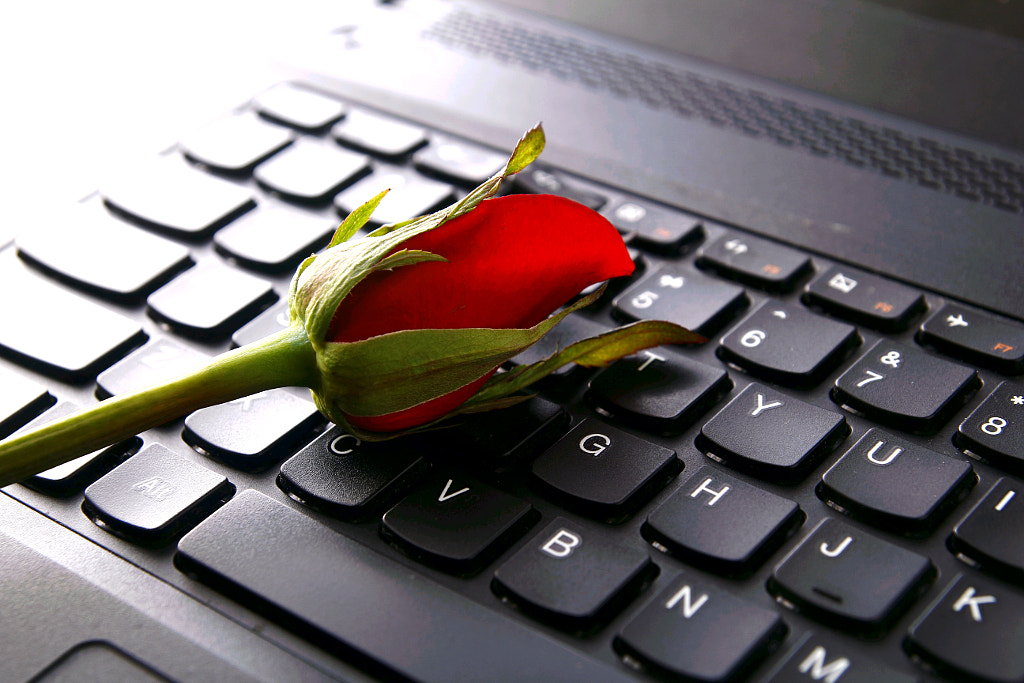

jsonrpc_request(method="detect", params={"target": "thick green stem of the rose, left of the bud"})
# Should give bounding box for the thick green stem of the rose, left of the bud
[0,325,319,486]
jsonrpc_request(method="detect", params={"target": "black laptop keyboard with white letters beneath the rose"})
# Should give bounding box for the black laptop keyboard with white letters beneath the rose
[0,84,1024,682]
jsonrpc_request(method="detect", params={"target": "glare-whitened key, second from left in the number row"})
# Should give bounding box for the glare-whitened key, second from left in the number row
[253,139,370,203]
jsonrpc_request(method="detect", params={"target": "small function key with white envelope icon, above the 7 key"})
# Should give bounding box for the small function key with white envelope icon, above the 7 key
[804,266,925,332]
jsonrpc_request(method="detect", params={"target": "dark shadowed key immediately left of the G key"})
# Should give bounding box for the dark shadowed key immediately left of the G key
[430,396,569,474]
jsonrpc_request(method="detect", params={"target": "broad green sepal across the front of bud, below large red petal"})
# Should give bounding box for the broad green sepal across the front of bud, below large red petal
[314,290,601,423]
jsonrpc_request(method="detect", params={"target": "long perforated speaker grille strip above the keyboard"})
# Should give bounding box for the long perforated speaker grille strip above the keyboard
[424,8,1024,214]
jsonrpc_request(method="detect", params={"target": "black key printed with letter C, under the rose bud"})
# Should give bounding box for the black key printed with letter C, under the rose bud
[278,427,427,521]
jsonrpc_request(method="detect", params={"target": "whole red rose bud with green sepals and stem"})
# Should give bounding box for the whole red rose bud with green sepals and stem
[0,127,701,485]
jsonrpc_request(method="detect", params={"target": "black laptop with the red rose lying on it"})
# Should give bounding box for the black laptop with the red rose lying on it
[0,0,1024,683]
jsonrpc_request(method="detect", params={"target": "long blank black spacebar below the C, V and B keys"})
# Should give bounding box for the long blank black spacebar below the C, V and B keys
[175,490,635,683]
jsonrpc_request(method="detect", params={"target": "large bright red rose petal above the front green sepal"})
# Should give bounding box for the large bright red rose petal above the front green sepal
[328,195,633,341]
